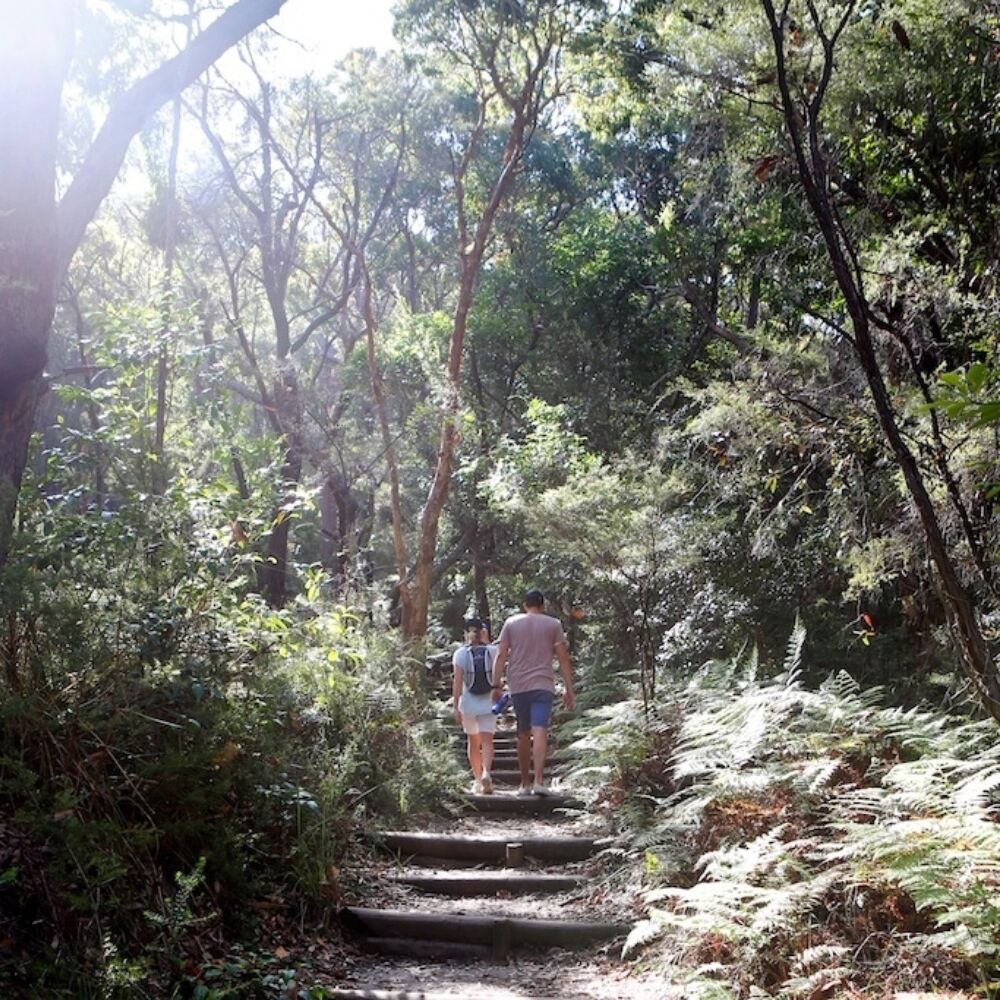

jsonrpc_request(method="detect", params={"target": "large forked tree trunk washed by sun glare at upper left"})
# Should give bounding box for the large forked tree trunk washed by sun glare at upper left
[0,0,285,567]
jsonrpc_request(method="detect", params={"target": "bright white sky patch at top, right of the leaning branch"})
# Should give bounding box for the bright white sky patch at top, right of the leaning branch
[271,0,395,74]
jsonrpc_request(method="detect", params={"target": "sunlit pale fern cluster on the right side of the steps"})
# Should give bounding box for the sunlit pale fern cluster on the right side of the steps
[578,626,1000,998]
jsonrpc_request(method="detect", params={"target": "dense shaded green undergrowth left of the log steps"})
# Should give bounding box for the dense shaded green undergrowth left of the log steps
[0,488,456,998]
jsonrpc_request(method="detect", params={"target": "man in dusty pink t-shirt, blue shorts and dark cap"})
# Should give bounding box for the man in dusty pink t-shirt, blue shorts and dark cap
[493,590,576,795]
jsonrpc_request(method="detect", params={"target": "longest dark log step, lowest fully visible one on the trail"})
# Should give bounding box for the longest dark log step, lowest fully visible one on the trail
[344,906,628,958]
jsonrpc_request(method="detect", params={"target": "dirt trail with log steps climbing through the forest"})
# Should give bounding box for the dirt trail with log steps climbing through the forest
[329,676,663,1000]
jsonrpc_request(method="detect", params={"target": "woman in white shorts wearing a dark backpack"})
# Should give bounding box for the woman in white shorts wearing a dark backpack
[452,618,497,795]
